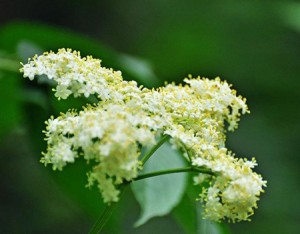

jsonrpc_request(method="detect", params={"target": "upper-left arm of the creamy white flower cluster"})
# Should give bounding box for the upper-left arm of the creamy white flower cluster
[21,49,122,100]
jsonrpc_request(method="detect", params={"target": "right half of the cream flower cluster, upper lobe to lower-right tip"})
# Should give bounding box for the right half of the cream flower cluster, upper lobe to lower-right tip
[142,77,266,222]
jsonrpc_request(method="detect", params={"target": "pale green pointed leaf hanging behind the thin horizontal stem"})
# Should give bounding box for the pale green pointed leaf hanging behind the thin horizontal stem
[131,144,187,226]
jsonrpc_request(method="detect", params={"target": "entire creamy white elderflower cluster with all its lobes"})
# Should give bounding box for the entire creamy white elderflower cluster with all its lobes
[21,49,266,222]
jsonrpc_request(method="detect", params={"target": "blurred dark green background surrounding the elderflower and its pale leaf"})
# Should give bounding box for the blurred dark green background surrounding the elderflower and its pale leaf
[0,0,300,234]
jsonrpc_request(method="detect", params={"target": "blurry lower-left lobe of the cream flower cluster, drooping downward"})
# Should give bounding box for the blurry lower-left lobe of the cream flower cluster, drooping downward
[43,104,155,202]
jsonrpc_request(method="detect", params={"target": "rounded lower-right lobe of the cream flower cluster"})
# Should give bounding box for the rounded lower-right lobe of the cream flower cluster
[193,152,266,222]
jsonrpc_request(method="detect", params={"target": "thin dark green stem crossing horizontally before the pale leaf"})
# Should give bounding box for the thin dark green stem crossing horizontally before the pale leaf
[133,167,215,181]
